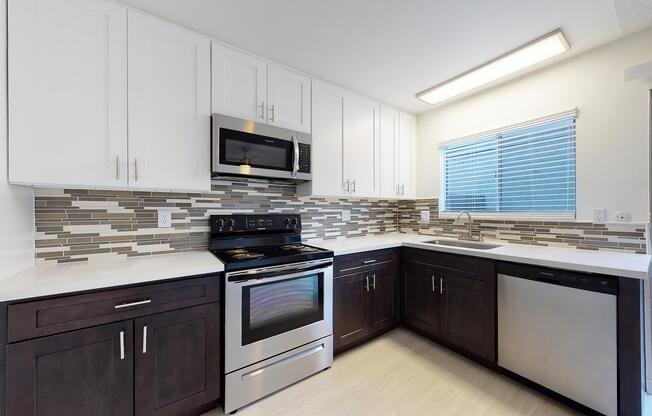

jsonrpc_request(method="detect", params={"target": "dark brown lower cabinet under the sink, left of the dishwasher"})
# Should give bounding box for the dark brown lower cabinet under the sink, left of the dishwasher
[402,249,496,365]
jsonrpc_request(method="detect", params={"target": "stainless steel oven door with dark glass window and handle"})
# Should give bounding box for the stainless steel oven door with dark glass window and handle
[224,259,333,373]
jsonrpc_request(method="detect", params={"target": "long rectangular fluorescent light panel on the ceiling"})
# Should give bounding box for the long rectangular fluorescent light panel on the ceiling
[417,30,570,104]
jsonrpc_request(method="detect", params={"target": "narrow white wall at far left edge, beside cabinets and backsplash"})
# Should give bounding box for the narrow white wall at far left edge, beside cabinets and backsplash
[0,0,37,279]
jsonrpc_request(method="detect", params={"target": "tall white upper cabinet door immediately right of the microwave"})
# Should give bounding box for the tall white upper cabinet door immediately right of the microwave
[311,81,344,196]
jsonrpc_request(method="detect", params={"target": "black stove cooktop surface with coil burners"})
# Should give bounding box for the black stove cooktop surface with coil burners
[212,243,333,271]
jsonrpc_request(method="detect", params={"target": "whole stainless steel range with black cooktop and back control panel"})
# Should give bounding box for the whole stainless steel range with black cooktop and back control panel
[210,214,333,413]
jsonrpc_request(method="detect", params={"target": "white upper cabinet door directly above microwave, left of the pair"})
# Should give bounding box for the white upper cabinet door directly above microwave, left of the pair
[212,43,267,123]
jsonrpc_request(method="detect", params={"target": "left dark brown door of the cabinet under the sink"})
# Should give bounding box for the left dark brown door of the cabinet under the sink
[403,266,439,336]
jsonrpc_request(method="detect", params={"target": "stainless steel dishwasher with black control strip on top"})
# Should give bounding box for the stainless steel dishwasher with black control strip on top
[497,263,618,415]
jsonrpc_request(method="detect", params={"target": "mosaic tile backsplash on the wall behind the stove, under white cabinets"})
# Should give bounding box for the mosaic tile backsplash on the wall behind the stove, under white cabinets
[35,180,398,263]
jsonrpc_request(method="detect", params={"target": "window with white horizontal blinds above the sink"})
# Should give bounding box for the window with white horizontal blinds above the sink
[440,112,577,217]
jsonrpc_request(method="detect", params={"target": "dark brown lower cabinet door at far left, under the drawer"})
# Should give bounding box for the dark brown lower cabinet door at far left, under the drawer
[7,321,134,416]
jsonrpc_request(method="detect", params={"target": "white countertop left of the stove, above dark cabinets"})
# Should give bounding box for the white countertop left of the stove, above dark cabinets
[0,251,224,302]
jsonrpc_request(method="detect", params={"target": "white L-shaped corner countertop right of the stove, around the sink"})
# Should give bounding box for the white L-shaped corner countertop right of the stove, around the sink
[308,233,652,280]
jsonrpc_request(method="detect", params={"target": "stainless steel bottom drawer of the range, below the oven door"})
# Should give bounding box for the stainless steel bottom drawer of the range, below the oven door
[224,336,333,413]
